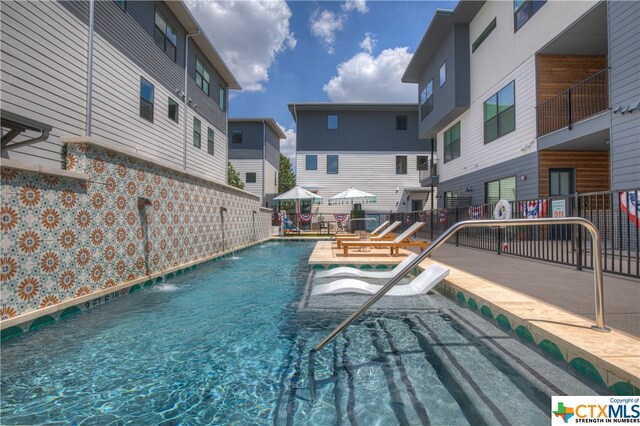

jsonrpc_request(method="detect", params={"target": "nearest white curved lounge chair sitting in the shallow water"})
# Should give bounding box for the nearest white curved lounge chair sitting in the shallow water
[311,264,449,296]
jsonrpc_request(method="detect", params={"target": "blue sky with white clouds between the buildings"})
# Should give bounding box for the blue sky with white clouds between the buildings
[182,0,457,158]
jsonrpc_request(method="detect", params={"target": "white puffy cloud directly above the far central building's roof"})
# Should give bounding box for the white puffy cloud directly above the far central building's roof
[322,47,418,102]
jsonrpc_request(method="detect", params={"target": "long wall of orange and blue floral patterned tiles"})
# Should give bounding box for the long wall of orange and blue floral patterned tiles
[0,144,271,320]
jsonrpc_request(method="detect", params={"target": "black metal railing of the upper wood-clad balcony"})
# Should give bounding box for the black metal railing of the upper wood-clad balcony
[536,68,609,137]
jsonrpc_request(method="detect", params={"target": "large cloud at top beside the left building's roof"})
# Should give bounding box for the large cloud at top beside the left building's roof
[187,0,297,92]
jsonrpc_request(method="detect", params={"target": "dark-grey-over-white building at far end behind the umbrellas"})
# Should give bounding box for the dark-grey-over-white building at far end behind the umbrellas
[289,103,433,213]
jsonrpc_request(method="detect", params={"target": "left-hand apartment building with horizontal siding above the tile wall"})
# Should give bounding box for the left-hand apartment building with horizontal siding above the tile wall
[1,0,240,183]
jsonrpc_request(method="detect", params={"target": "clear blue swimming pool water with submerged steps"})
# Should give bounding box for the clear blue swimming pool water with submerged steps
[0,242,607,424]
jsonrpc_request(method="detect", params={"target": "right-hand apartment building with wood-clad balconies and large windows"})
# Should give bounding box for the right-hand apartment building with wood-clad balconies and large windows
[402,0,640,207]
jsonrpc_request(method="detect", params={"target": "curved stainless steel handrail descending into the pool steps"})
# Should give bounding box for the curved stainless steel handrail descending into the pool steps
[307,217,611,400]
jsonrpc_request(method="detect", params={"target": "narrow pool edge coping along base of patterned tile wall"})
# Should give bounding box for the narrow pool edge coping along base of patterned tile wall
[0,237,273,341]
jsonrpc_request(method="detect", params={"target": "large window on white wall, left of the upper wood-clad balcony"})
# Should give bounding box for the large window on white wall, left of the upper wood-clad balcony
[484,81,516,143]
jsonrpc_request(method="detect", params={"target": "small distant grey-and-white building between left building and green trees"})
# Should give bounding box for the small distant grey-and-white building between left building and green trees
[228,118,287,207]
